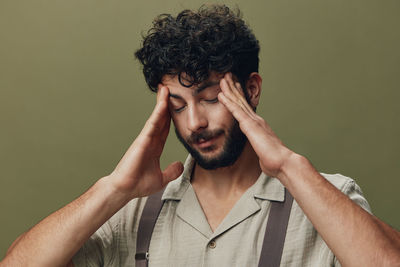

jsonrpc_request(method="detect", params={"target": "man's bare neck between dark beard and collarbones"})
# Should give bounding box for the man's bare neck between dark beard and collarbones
[191,142,261,198]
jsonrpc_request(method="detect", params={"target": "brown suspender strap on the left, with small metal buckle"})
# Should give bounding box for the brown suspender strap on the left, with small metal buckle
[135,190,164,267]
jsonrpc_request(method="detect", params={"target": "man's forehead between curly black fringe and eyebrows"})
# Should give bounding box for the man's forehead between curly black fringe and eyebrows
[161,73,224,95]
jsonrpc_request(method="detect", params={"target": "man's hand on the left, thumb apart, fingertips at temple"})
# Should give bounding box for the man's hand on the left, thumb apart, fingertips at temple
[108,85,183,199]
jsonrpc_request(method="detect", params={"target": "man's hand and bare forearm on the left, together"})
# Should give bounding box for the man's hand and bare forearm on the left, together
[0,86,183,267]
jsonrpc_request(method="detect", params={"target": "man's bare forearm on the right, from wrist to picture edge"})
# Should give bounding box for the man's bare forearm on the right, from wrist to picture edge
[278,154,400,266]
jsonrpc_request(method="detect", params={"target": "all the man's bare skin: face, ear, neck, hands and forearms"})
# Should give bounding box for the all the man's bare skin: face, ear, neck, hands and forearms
[0,73,400,266]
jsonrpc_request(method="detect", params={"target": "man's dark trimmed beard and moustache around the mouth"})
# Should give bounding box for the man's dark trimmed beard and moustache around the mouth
[175,119,247,170]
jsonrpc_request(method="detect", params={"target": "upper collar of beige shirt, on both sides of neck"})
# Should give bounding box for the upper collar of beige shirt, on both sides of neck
[161,155,285,202]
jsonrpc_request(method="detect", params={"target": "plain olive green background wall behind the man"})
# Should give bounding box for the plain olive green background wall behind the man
[0,0,400,258]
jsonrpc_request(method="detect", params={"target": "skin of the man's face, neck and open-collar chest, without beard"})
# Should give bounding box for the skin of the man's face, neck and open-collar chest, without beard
[163,75,261,231]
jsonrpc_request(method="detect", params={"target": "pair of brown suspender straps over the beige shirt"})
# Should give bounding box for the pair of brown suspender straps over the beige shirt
[135,189,293,267]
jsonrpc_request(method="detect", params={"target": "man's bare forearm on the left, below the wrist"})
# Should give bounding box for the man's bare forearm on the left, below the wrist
[0,177,129,266]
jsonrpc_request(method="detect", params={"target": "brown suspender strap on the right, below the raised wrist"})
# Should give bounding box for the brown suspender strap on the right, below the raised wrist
[258,188,293,267]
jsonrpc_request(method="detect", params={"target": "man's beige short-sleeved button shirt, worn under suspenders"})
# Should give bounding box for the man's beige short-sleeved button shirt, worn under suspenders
[73,156,370,267]
